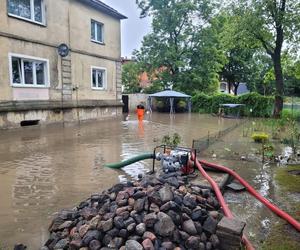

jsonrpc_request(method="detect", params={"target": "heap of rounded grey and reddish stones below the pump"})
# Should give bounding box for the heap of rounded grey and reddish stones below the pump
[41,172,244,250]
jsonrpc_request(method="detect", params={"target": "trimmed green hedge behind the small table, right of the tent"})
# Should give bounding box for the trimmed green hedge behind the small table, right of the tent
[192,93,274,117]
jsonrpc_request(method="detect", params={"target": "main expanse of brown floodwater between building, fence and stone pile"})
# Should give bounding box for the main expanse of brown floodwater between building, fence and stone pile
[0,113,237,250]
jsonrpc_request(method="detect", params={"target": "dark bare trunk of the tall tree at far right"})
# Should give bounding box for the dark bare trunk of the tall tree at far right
[272,53,284,118]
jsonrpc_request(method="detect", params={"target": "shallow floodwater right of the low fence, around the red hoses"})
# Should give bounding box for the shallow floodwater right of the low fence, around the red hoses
[202,126,300,249]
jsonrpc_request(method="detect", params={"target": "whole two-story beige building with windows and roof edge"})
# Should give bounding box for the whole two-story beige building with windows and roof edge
[0,0,126,128]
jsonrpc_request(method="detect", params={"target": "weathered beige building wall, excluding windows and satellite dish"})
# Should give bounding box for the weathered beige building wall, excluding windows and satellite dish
[0,0,121,127]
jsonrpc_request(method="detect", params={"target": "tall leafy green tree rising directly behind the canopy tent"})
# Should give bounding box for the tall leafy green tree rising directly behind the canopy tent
[135,0,220,91]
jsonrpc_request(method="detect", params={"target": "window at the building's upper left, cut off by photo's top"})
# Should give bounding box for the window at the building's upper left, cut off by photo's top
[8,0,45,24]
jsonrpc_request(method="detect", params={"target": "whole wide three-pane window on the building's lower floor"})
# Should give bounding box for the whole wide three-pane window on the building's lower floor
[10,54,49,87]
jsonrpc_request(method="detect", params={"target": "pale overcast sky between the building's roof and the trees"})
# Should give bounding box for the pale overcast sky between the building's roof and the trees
[101,0,151,57]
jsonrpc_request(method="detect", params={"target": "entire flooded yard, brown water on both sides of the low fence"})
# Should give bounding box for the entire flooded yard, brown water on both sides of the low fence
[0,113,300,250]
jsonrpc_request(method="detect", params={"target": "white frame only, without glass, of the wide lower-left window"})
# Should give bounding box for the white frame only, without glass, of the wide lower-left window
[8,53,50,88]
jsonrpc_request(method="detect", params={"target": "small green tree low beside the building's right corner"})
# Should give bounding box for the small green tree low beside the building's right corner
[122,62,142,93]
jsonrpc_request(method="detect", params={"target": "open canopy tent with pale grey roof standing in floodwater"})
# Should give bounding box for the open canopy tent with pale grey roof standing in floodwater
[148,90,192,114]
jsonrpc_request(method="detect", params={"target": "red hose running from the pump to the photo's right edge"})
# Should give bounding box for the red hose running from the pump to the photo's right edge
[196,160,300,231]
